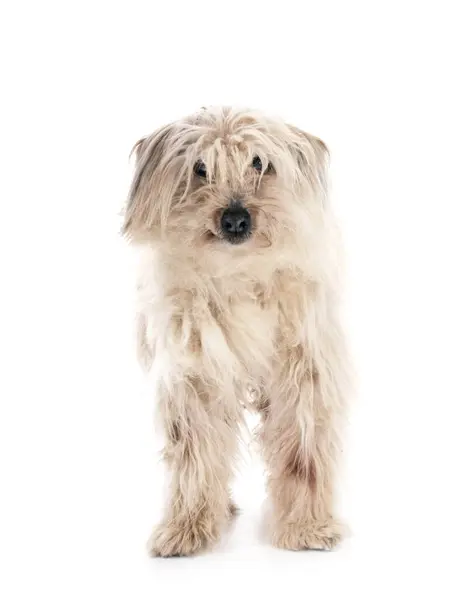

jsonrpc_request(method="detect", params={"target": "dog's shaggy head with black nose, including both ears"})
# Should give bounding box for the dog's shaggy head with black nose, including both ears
[124,108,328,255]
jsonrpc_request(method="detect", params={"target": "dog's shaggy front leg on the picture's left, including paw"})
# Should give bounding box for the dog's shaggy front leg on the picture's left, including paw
[148,377,238,556]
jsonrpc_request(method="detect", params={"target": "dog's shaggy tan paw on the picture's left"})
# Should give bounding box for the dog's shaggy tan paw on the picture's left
[147,520,219,557]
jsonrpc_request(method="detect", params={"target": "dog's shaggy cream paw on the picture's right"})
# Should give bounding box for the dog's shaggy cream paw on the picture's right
[273,520,346,550]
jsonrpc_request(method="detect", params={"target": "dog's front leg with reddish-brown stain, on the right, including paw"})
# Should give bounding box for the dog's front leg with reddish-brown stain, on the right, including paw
[263,330,343,550]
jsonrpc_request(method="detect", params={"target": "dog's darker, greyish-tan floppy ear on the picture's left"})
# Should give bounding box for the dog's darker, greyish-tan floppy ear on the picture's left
[122,125,171,237]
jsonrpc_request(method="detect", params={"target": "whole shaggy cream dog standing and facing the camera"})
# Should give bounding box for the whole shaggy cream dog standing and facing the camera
[123,107,348,557]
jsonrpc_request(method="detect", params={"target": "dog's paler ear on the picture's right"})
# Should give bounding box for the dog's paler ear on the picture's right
[291,127,330,205]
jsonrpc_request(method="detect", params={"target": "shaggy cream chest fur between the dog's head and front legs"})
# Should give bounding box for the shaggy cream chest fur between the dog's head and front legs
[139,250,308,382]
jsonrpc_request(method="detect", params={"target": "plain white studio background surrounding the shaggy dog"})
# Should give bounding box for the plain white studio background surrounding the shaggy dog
[0,0,468,600]
